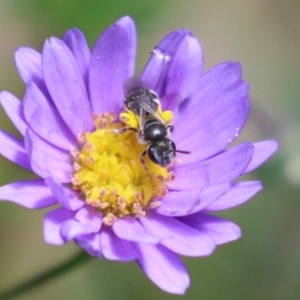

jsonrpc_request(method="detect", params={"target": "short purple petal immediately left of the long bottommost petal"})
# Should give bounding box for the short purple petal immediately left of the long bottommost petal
[101,228,138,261]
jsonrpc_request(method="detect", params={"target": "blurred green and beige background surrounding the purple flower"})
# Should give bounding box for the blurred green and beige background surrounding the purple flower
[0,0,300,300]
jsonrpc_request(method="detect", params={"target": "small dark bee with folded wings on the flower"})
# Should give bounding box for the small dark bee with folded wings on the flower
[124,77,177,167]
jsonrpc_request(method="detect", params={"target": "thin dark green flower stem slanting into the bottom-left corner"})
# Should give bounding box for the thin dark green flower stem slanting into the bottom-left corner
[0,251,92,300]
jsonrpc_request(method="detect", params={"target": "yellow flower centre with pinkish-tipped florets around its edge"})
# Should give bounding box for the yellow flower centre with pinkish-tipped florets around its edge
[71,112,173,225]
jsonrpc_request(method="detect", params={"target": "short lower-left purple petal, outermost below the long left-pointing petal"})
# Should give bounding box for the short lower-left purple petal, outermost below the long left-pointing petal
[44,208,75,245]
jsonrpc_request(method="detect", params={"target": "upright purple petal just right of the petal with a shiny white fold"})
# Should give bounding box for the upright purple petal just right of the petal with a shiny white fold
[163,36,203,112]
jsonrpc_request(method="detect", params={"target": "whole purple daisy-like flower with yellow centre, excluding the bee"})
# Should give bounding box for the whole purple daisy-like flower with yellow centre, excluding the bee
[0,17,277,294]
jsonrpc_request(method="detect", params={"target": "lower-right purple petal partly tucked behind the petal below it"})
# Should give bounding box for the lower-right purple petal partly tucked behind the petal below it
[180,212,242,245]
